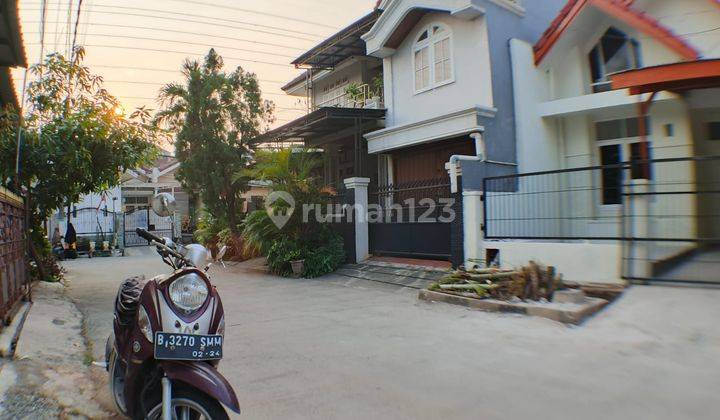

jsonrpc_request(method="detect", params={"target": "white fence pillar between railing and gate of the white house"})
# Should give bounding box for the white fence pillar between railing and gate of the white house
[628,179,652,280]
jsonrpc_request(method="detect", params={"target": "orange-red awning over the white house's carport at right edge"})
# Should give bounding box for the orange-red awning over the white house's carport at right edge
[610,60,720,95]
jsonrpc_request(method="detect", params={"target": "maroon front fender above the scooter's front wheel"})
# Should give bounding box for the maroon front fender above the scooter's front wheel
[160,360,240,414]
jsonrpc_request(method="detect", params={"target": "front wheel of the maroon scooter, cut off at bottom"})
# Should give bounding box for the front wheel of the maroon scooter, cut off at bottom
[146,388,229,420]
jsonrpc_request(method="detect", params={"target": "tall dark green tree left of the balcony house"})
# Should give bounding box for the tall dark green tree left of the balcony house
[156,49,274,233]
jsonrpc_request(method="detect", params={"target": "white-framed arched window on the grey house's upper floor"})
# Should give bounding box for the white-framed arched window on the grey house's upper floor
[413,23,454,93]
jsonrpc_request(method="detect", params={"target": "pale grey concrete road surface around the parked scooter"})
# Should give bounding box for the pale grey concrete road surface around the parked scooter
[65,251,720,420]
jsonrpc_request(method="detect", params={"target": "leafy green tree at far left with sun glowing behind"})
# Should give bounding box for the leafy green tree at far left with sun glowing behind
[0,47,156,270]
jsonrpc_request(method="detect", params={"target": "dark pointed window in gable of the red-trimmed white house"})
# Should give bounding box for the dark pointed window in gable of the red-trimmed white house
[590,27,642,92]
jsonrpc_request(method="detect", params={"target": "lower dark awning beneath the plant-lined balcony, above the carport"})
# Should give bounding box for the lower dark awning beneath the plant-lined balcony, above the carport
[257,107,385,143]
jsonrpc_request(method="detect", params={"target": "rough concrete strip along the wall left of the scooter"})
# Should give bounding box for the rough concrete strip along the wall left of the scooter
[0,283,112,419]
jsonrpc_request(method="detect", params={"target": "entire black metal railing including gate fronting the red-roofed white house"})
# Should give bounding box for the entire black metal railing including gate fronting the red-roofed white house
[483,157,720,284]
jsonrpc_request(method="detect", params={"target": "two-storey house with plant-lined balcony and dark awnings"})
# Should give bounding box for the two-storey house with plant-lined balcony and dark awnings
[260,10,385,188]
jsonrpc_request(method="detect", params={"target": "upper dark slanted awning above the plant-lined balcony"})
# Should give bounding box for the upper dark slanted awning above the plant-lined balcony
[292,10,381,69]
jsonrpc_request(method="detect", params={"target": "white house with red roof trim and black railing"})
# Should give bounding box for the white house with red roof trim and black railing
[480,0,720,282]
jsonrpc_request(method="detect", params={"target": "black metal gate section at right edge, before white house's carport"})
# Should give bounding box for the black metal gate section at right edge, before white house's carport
[623,157,720,284]
